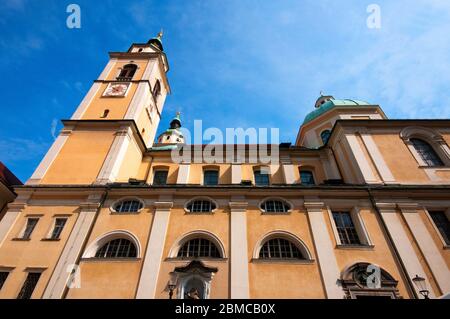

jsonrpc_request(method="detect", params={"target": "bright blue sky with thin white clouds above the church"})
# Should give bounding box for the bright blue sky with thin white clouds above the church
[0,0,450,181]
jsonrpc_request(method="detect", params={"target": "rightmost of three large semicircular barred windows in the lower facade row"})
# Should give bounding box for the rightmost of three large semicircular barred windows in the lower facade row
[259,238,306,259]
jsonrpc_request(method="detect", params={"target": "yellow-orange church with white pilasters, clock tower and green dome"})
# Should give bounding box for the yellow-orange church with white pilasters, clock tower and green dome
[0,34,450,299]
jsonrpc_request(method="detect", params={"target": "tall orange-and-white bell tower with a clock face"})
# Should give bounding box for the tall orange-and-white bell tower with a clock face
[27,31,170,184]
